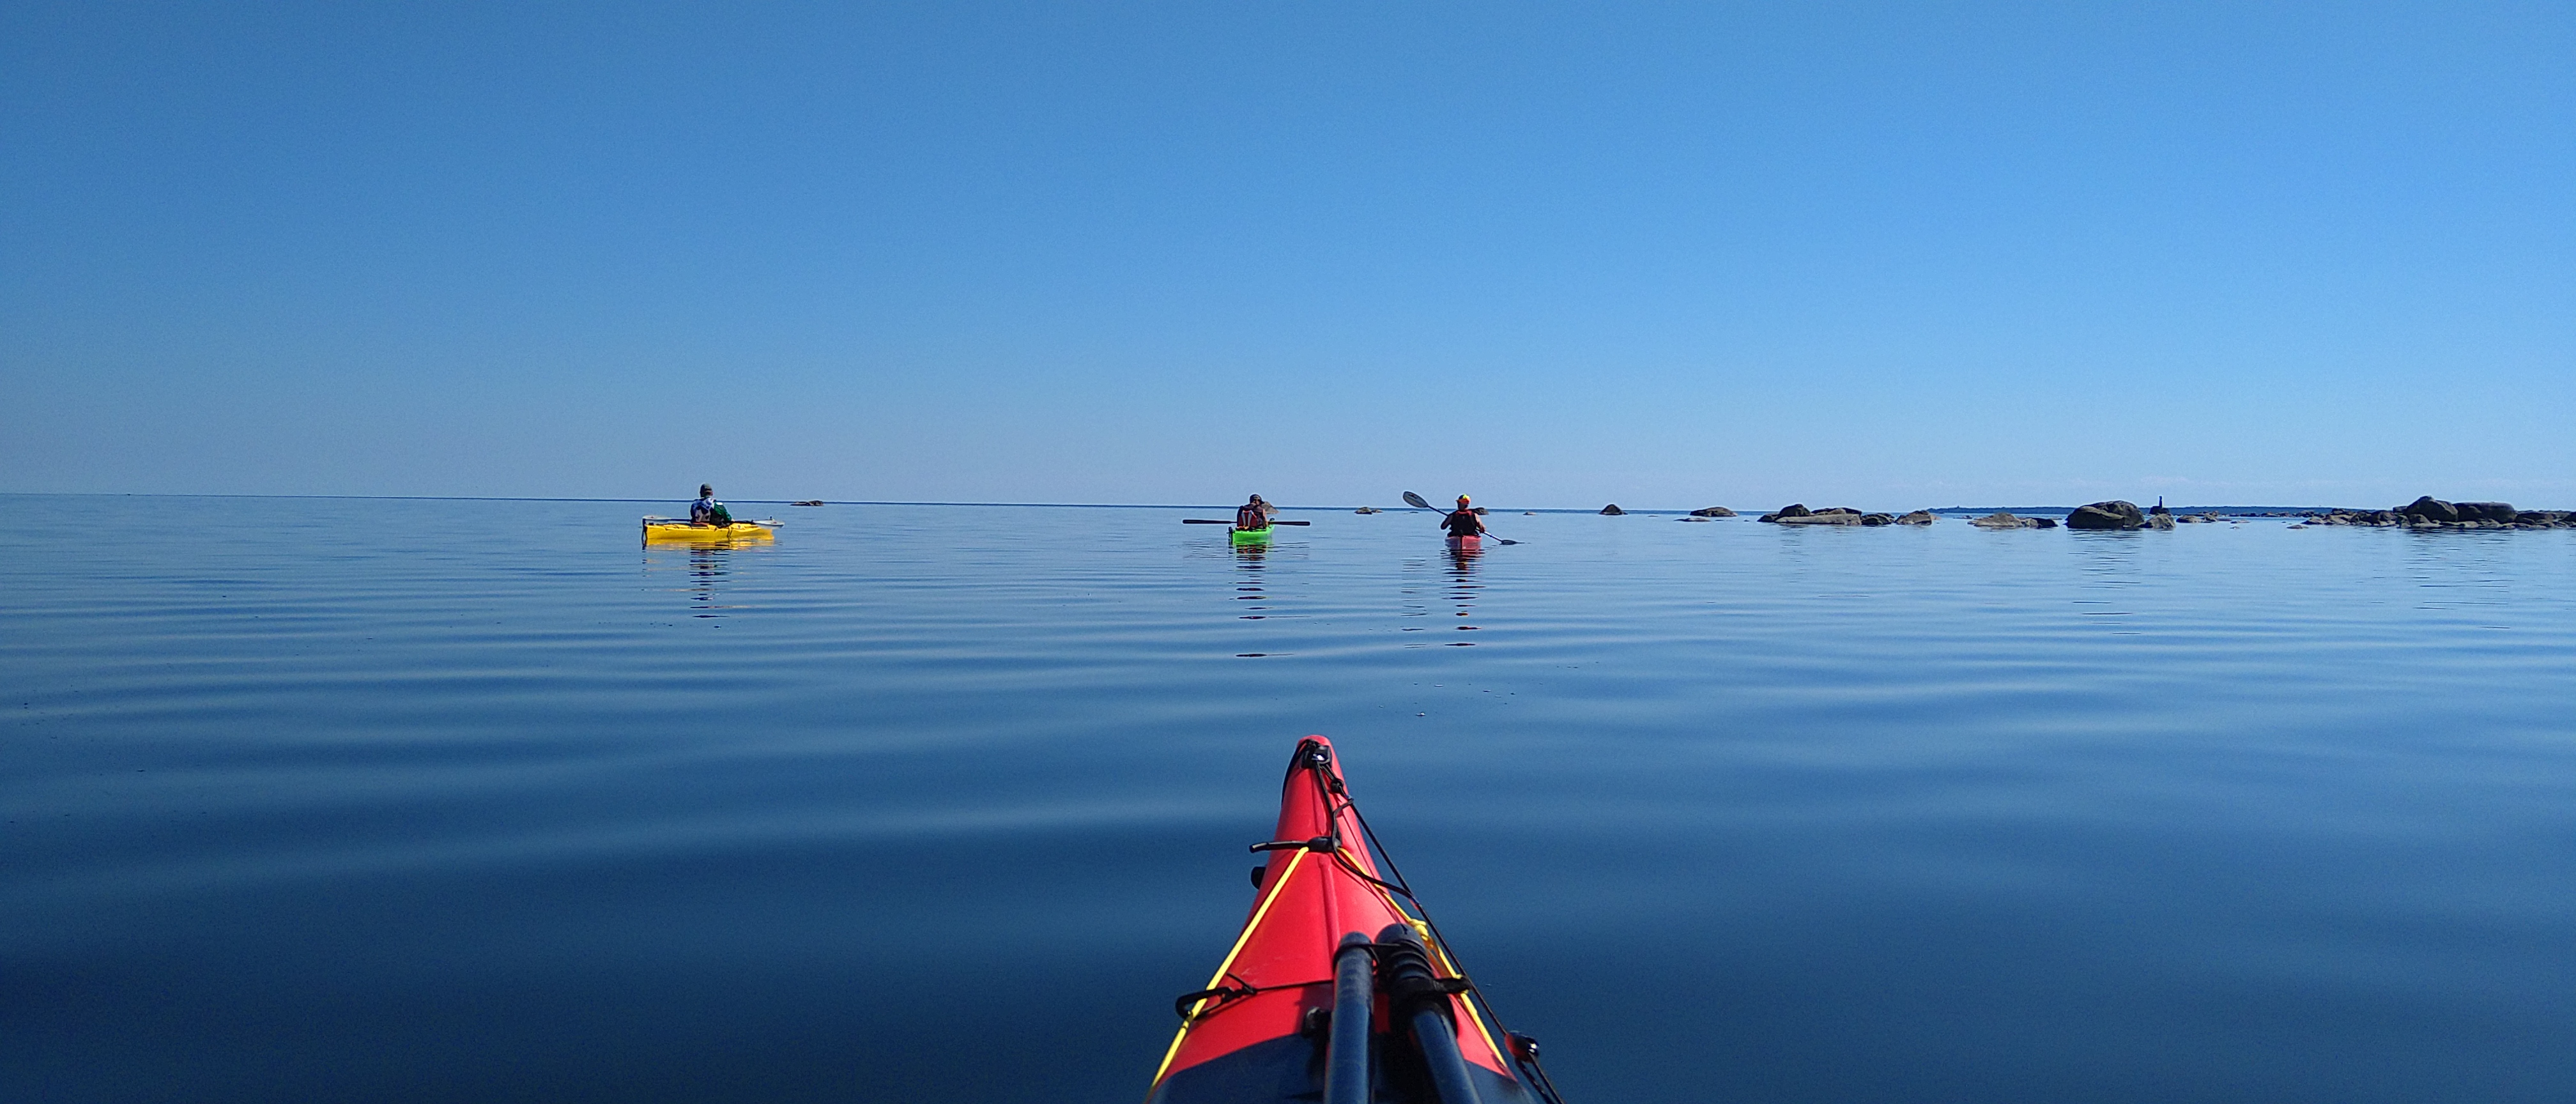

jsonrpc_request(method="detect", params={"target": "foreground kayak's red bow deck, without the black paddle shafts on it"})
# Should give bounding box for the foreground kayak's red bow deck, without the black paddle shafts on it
[1146,736,1556,1104]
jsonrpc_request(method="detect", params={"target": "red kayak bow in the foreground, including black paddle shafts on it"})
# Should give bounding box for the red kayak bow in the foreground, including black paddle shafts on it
[1146,736,1563,1104]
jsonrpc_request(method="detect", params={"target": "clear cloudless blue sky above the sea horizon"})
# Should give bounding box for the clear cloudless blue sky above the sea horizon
[0,3,2576,507]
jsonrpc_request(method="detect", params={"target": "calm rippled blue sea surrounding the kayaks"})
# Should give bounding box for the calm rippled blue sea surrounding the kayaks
[0,496,2576,1104]
